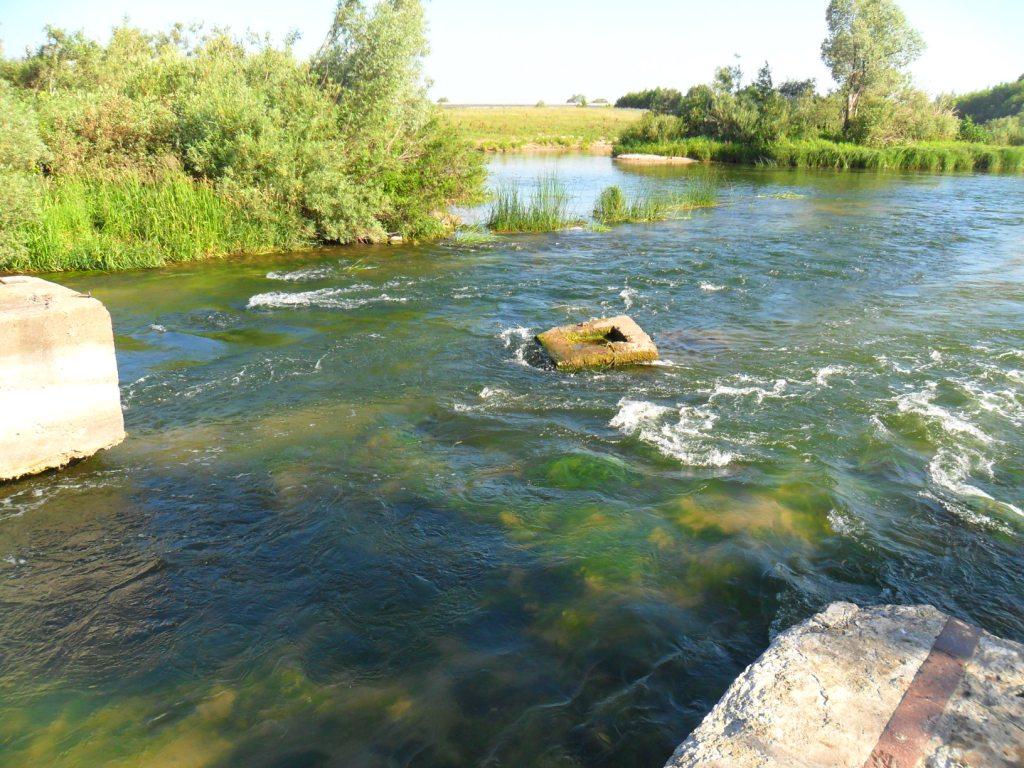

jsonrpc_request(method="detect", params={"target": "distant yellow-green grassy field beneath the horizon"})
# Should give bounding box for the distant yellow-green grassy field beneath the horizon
[444,106,643,152]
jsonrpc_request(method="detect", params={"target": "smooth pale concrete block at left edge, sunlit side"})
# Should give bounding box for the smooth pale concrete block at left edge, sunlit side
[0,276,125,481]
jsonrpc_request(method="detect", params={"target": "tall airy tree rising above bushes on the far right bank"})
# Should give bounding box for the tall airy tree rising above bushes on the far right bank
[821,0,925,131]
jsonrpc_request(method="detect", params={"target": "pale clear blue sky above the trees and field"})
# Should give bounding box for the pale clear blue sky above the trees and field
[0,0,1024,103]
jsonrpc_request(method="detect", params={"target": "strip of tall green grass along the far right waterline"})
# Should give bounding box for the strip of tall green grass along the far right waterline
[613,137,1024,173]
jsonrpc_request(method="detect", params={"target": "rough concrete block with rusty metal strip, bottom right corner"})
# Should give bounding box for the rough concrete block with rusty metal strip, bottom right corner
[667,603,1024,768]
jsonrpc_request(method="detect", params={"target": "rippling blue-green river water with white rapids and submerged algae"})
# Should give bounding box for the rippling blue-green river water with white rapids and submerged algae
[0,157,1024,768]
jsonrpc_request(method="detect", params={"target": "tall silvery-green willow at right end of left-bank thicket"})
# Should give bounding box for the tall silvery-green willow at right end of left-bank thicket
[311,0,484,240]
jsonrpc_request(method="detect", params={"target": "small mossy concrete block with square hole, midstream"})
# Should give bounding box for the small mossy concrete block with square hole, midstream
[537,314,657,371]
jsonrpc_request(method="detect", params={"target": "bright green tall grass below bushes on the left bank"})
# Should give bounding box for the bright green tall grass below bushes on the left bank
[0,177,305,271]
